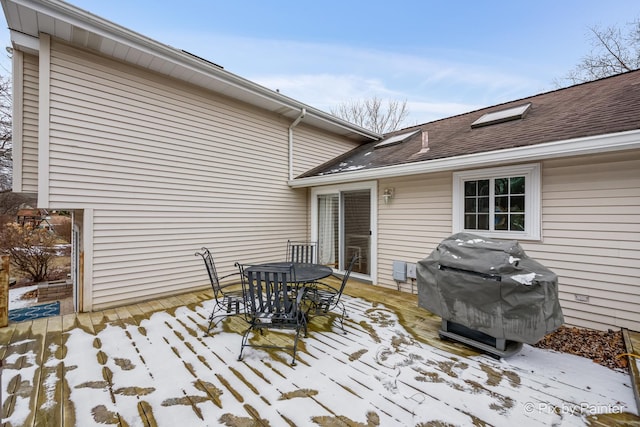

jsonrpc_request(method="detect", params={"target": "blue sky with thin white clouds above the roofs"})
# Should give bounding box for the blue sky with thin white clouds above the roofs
[2,0,640,125]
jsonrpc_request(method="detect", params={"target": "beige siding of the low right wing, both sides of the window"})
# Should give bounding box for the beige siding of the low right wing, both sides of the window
[378,151,640,330]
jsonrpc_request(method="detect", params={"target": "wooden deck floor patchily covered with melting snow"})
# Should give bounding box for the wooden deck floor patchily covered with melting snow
[0,281,640,427]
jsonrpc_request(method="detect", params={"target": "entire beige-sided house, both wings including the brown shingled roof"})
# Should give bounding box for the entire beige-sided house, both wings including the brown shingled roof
[0,0,640,330]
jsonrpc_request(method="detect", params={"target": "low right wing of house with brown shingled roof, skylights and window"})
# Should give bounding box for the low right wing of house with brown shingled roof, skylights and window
[291,71,640,330]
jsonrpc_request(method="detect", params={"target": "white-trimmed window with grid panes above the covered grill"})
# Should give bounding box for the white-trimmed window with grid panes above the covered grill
[453,164,541,240]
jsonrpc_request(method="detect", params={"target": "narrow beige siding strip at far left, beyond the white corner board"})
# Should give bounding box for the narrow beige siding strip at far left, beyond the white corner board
[22,54,39,193]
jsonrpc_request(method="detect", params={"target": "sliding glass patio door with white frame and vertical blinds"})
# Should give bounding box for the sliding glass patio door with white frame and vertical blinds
[312,182,375,276]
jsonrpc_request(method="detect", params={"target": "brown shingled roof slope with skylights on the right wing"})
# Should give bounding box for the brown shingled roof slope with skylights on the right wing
[299,71,640,178]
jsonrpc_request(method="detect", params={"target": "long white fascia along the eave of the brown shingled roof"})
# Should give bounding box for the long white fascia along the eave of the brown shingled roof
[288,130,640,188]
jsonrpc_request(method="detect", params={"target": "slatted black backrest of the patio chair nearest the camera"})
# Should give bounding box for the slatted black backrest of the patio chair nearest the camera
[242,265,298,320]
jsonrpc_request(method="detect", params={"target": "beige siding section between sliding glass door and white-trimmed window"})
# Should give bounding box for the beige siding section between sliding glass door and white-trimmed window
[378,173,452,293]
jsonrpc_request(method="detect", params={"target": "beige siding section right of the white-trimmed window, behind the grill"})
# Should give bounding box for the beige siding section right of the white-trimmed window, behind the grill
[523,151,640,330]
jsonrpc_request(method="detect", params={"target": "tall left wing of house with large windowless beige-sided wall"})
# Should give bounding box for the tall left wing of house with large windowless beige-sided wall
[1,0,380,311]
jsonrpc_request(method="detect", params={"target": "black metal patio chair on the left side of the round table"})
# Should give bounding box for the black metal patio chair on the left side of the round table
[195,247,244,334]
